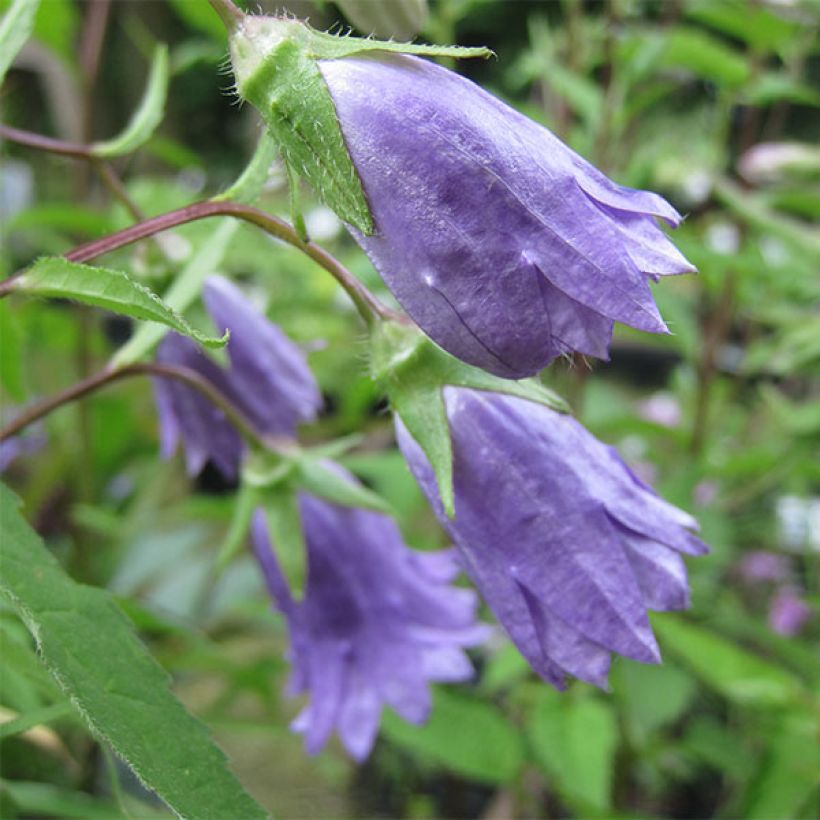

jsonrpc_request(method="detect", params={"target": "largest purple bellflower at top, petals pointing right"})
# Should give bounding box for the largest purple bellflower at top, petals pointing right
[319,52,694,378]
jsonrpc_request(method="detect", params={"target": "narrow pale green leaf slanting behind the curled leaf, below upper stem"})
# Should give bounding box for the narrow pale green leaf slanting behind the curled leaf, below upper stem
[111,219,239,367]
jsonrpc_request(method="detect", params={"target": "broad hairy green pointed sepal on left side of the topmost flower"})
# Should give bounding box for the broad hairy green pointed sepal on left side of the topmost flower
[235,33,373,234]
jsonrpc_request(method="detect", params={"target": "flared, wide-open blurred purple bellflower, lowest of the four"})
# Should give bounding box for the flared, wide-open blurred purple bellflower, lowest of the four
[252,484,487,760]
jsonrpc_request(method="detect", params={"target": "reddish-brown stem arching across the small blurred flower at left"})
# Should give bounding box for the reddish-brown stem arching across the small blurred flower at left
[0,362,265,445]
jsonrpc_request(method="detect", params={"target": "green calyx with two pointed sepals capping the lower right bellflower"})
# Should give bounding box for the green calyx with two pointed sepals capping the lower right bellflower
[371,322,569,518]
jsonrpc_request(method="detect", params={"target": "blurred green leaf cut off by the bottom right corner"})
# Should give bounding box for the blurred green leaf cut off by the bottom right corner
[741,711,820,820]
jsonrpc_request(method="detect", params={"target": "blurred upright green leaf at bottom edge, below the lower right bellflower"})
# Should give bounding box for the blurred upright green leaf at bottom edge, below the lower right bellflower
[528,688,618,816]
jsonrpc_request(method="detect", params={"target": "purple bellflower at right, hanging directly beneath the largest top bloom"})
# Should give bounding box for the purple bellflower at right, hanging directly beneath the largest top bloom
[397,387,706,688]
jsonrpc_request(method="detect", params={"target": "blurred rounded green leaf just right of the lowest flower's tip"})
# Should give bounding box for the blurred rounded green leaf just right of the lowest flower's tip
[382,688,524,783]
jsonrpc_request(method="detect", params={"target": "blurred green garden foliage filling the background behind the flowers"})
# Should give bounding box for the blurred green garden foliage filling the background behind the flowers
[0,0,820,818]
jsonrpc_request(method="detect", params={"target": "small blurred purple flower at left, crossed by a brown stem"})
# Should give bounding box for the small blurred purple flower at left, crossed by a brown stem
[155,276,322,478]
